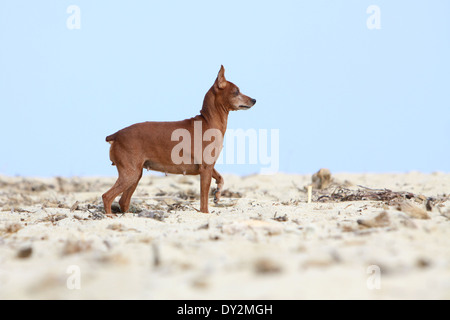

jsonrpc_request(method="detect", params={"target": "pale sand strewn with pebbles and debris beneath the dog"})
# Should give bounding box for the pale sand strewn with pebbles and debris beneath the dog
[0,172,450,299]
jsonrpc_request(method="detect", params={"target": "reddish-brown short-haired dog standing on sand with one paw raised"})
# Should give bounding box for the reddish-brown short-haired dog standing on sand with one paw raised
[103,66,256,215]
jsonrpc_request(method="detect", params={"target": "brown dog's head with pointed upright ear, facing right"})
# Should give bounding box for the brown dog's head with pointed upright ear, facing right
[214,66,256,111]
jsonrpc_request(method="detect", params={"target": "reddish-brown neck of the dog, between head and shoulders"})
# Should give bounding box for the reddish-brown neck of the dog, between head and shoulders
[200,88,229,135]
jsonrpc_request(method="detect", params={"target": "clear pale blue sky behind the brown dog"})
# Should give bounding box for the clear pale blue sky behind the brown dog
[0,0,450,176]
